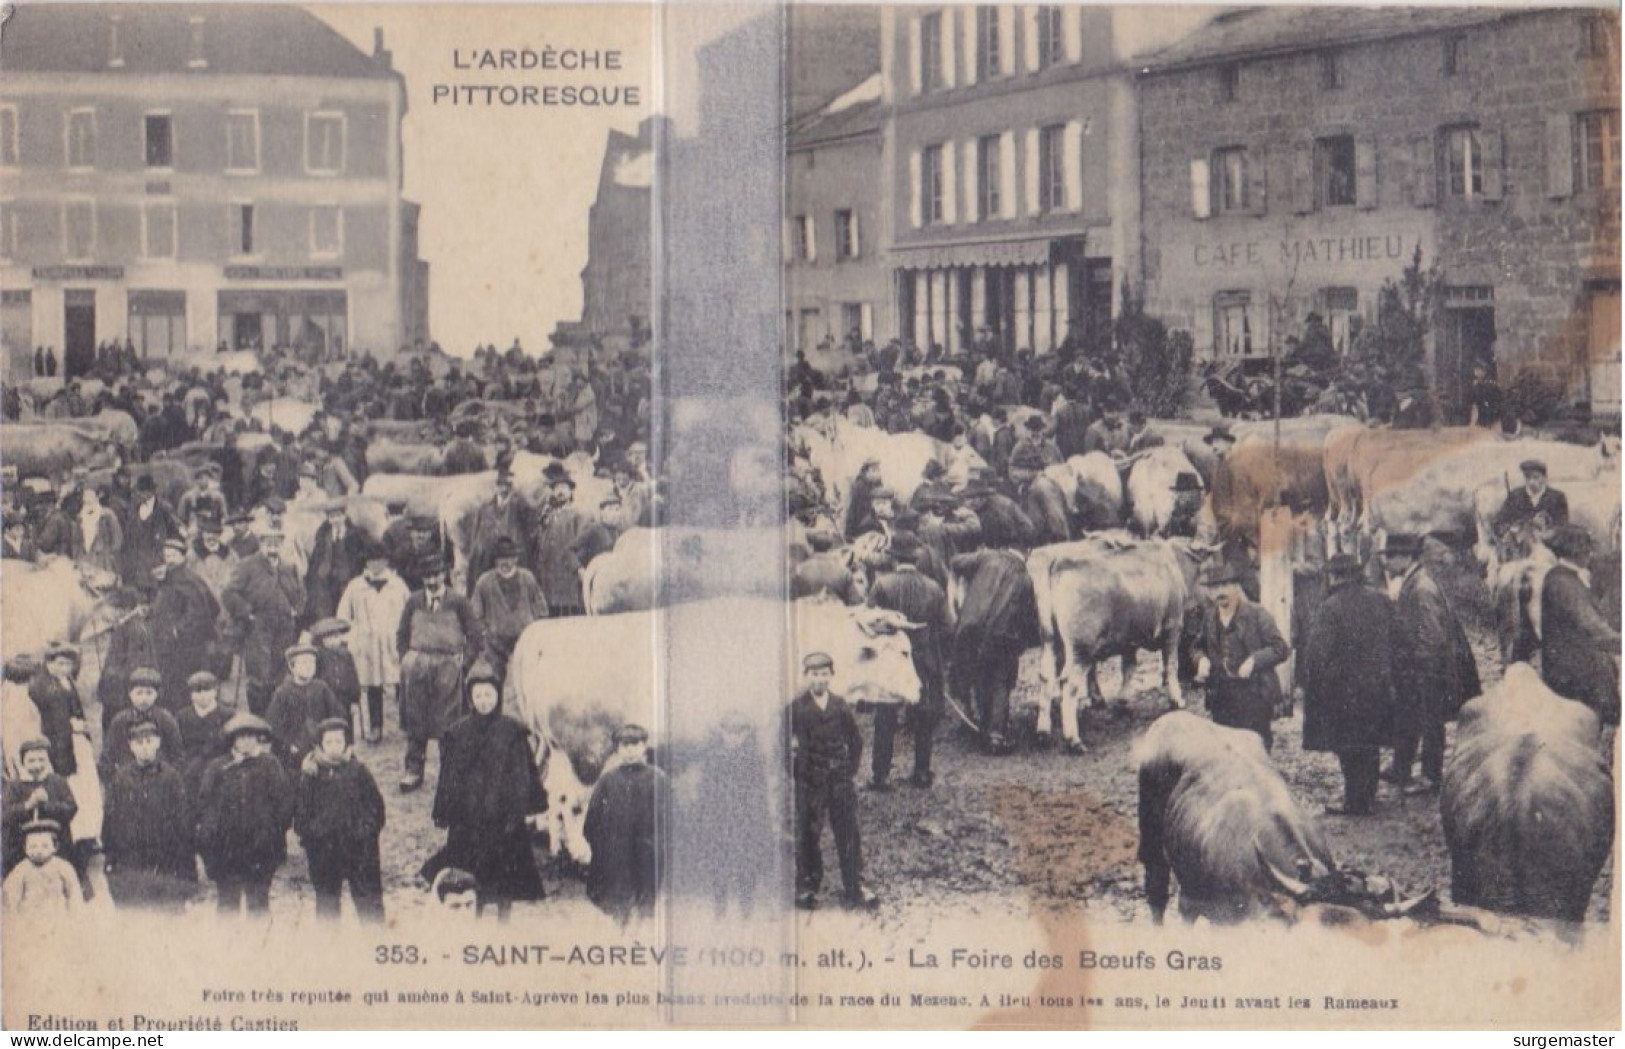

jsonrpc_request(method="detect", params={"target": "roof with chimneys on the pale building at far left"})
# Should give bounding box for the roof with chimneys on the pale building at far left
[0,3,395,80]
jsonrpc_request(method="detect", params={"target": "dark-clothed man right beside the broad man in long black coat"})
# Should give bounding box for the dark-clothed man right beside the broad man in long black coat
[1383,533,1479,794]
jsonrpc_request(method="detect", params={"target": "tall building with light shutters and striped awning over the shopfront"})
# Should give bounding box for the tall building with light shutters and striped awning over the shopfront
[881,5,1206,352]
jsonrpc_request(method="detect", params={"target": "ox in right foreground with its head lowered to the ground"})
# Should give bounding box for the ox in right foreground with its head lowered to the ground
[1136,711,1432,924]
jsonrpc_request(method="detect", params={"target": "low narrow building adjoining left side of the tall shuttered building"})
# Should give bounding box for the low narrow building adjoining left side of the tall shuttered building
[783,73,887,351]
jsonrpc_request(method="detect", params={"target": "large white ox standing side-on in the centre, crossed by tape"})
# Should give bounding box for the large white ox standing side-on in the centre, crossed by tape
[505,598,920,862]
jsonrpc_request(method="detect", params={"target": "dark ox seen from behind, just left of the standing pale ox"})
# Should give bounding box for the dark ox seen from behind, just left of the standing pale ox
[949,549,1040,755]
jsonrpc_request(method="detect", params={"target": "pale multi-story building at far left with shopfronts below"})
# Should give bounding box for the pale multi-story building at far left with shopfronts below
[0,3,427,375]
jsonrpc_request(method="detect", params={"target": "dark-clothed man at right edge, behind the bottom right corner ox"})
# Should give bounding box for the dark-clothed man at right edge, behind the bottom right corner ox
[1541,525,1620,724]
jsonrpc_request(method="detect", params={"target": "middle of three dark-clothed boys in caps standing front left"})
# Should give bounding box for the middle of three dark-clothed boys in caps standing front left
[197,711,294,914]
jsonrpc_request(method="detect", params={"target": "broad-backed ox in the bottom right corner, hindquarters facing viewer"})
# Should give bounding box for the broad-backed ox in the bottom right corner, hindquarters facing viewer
[1440,663,1614,922]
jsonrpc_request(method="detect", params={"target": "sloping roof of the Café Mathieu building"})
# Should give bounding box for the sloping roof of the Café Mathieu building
[1139,5,1519,73]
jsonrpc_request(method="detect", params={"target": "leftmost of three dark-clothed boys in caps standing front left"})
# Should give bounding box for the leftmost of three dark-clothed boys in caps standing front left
[102,718,198,913]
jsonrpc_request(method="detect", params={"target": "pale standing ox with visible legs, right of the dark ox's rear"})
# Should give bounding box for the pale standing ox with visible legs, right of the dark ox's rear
[1027,533,1206,750]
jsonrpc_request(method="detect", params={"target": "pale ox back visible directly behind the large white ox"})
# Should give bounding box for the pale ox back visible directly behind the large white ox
[582,528,790,615]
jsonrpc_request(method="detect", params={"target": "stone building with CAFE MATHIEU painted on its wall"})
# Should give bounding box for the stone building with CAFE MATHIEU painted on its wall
[1139,6,1620,417]
